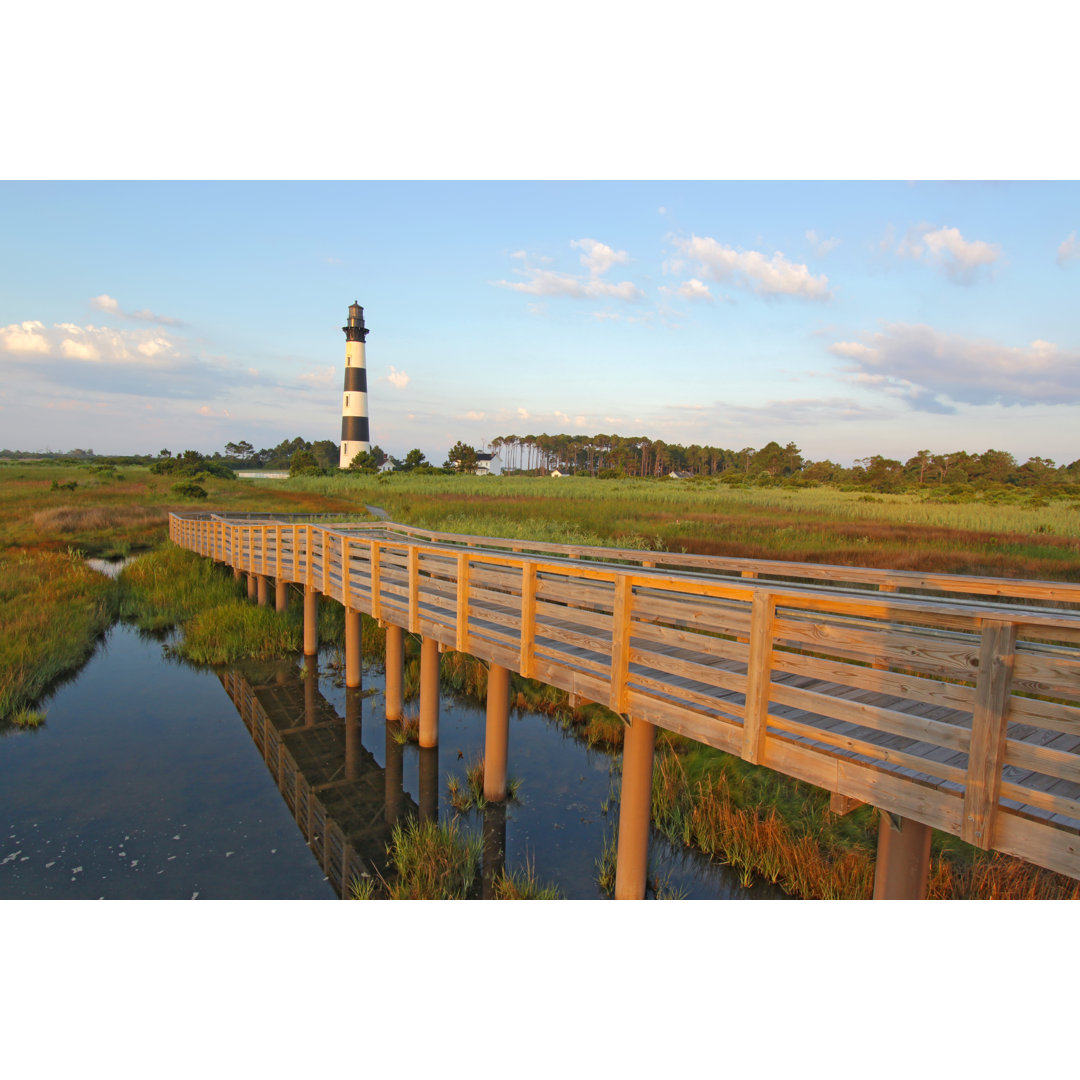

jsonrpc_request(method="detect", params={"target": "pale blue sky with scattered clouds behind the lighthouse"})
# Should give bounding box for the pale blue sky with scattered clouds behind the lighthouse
[0,180,1080,462]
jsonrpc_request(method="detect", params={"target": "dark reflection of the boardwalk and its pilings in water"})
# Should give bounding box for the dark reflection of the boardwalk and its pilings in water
[219,657,416,896]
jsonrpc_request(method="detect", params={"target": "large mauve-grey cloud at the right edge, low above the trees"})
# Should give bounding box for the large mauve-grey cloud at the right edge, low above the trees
[829,323,1080,413]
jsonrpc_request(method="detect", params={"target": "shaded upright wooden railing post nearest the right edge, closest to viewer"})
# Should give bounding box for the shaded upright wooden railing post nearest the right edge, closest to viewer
[960,621,1016,850]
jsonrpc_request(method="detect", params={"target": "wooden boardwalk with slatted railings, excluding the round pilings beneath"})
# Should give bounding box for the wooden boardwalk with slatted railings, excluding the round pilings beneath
[170,514,1080,878]
